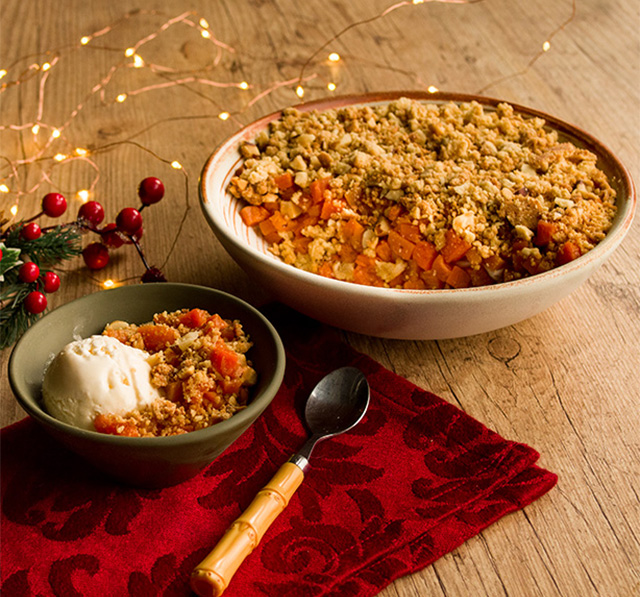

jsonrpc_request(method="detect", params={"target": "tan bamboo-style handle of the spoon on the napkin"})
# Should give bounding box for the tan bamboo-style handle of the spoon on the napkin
[191,462,304,597]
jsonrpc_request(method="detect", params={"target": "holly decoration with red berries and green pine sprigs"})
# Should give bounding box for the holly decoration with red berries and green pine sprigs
[0,177,166,349]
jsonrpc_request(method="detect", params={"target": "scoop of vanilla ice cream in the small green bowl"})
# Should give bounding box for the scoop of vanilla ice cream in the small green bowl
[42,336,160,430]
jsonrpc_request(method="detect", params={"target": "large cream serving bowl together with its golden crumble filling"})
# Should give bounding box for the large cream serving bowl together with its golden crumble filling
[200,92,636,340]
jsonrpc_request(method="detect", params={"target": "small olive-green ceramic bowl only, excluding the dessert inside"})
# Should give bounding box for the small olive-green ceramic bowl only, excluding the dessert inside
[9,283,285,487]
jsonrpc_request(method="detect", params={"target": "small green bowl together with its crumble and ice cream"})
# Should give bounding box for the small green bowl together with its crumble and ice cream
[9,283,285,487]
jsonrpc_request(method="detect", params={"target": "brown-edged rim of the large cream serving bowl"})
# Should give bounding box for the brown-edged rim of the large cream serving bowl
[198,91,637,301]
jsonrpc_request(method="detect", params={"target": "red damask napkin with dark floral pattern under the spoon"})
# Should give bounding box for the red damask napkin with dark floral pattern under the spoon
[1,310,557,597]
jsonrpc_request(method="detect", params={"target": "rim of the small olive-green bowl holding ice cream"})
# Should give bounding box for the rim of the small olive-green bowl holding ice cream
[8,282,286,448]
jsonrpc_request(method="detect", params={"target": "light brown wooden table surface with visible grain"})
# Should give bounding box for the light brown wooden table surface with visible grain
[0,0,640,597]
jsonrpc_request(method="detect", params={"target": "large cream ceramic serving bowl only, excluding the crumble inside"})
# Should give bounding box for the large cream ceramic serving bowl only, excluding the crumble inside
[200,92,636,340]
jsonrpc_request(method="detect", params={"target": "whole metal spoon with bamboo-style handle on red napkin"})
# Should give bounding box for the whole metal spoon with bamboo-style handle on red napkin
[191,367,369,597]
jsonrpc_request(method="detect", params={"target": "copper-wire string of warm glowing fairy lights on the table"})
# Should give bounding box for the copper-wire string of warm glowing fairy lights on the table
[0,0,576,287]
